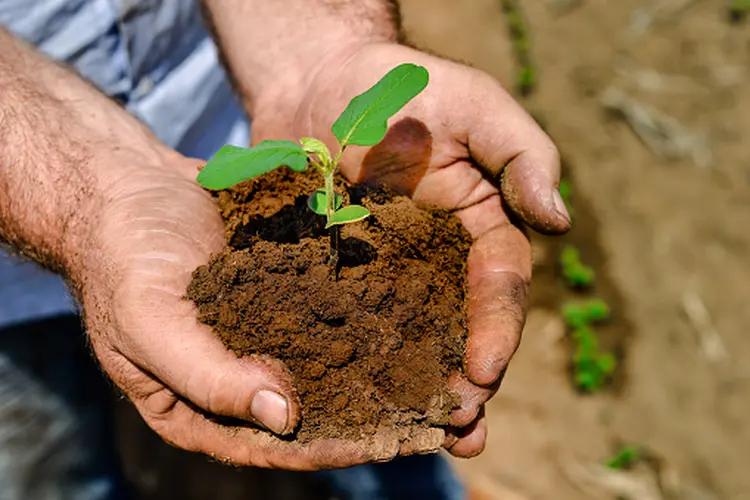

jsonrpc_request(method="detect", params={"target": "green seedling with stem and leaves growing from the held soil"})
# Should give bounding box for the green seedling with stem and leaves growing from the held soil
[197,64,429,270]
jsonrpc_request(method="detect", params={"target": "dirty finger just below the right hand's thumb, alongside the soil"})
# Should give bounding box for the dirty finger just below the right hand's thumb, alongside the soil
[458,196,531,387]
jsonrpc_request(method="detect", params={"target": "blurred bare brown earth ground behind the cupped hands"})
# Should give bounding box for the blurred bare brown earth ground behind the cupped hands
[119,0,750,500]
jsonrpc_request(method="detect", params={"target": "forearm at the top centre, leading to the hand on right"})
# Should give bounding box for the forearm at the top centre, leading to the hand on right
[203,0,401,113]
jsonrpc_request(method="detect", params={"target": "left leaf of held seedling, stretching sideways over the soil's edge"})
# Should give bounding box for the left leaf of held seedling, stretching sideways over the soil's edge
[197,141,307,189]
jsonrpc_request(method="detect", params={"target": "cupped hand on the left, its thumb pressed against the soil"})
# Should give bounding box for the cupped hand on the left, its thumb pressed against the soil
[74,148,442,470]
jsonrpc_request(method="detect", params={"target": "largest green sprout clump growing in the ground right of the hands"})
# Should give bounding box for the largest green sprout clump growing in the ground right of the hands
[562,299,617,392]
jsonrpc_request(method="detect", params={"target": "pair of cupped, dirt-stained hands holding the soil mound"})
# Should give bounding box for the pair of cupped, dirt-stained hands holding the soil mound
[81,44,570,470]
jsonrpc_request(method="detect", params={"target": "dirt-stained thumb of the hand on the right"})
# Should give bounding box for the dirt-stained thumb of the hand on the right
[465,73,570,234]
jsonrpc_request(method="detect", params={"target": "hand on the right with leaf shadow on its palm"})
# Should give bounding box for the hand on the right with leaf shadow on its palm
[252,43,570,457]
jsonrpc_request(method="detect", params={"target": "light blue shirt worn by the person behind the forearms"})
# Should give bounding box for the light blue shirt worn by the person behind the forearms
[0,0,249,327]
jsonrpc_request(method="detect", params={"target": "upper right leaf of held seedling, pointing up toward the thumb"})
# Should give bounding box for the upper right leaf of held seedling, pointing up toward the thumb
[331,64,430,148]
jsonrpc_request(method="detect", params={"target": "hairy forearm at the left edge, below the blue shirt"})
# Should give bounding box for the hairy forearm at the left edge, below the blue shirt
[0,29,167,278]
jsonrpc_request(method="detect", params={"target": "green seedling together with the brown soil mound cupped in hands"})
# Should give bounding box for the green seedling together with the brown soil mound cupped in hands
[186,64,471,446]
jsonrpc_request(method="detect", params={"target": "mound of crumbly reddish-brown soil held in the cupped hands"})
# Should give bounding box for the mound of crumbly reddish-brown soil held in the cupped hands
[187,169,470,442]
